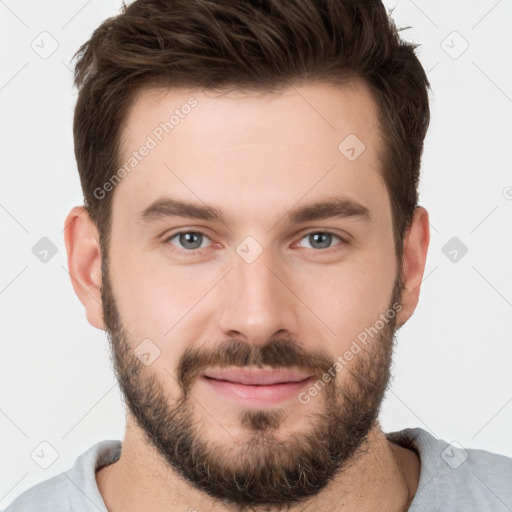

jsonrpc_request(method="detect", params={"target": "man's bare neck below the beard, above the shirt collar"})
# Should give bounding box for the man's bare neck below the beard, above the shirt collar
[96,422,420,512]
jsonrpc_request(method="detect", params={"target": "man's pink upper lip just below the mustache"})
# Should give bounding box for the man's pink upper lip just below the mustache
[204,368,311,386]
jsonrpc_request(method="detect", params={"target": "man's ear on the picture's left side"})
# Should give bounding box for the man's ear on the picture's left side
[64,206,105,330]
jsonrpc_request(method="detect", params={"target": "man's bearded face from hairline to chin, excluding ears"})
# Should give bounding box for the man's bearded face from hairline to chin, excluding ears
[102,83,401,506]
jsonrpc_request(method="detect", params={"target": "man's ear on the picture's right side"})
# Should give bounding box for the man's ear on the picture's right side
[397,206,430,326]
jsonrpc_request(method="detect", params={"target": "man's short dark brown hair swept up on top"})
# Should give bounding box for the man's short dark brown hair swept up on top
[73,0,430,258]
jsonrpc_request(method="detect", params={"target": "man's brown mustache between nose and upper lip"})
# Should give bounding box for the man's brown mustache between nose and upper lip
[177,338,334,396]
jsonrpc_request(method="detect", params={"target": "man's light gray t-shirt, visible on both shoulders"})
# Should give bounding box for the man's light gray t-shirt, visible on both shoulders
[5,428,512,512]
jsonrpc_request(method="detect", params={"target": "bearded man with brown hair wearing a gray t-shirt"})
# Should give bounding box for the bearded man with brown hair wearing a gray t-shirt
[8,0,512,512]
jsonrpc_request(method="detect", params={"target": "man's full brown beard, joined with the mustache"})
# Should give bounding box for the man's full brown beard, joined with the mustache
[101,252,403,510]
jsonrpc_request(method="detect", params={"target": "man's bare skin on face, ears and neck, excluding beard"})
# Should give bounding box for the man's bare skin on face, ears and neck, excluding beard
[65,78,429,512]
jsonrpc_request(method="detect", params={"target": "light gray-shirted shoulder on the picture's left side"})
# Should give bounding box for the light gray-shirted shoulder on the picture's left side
[4,440,121,512]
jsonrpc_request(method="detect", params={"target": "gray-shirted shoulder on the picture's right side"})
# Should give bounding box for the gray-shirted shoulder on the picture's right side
[388,428,512,512]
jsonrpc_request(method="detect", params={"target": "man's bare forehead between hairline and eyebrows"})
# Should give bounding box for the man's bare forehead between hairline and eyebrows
[113,81,388,230]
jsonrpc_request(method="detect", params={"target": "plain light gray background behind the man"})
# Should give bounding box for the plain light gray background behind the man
[0,0,512,508]
